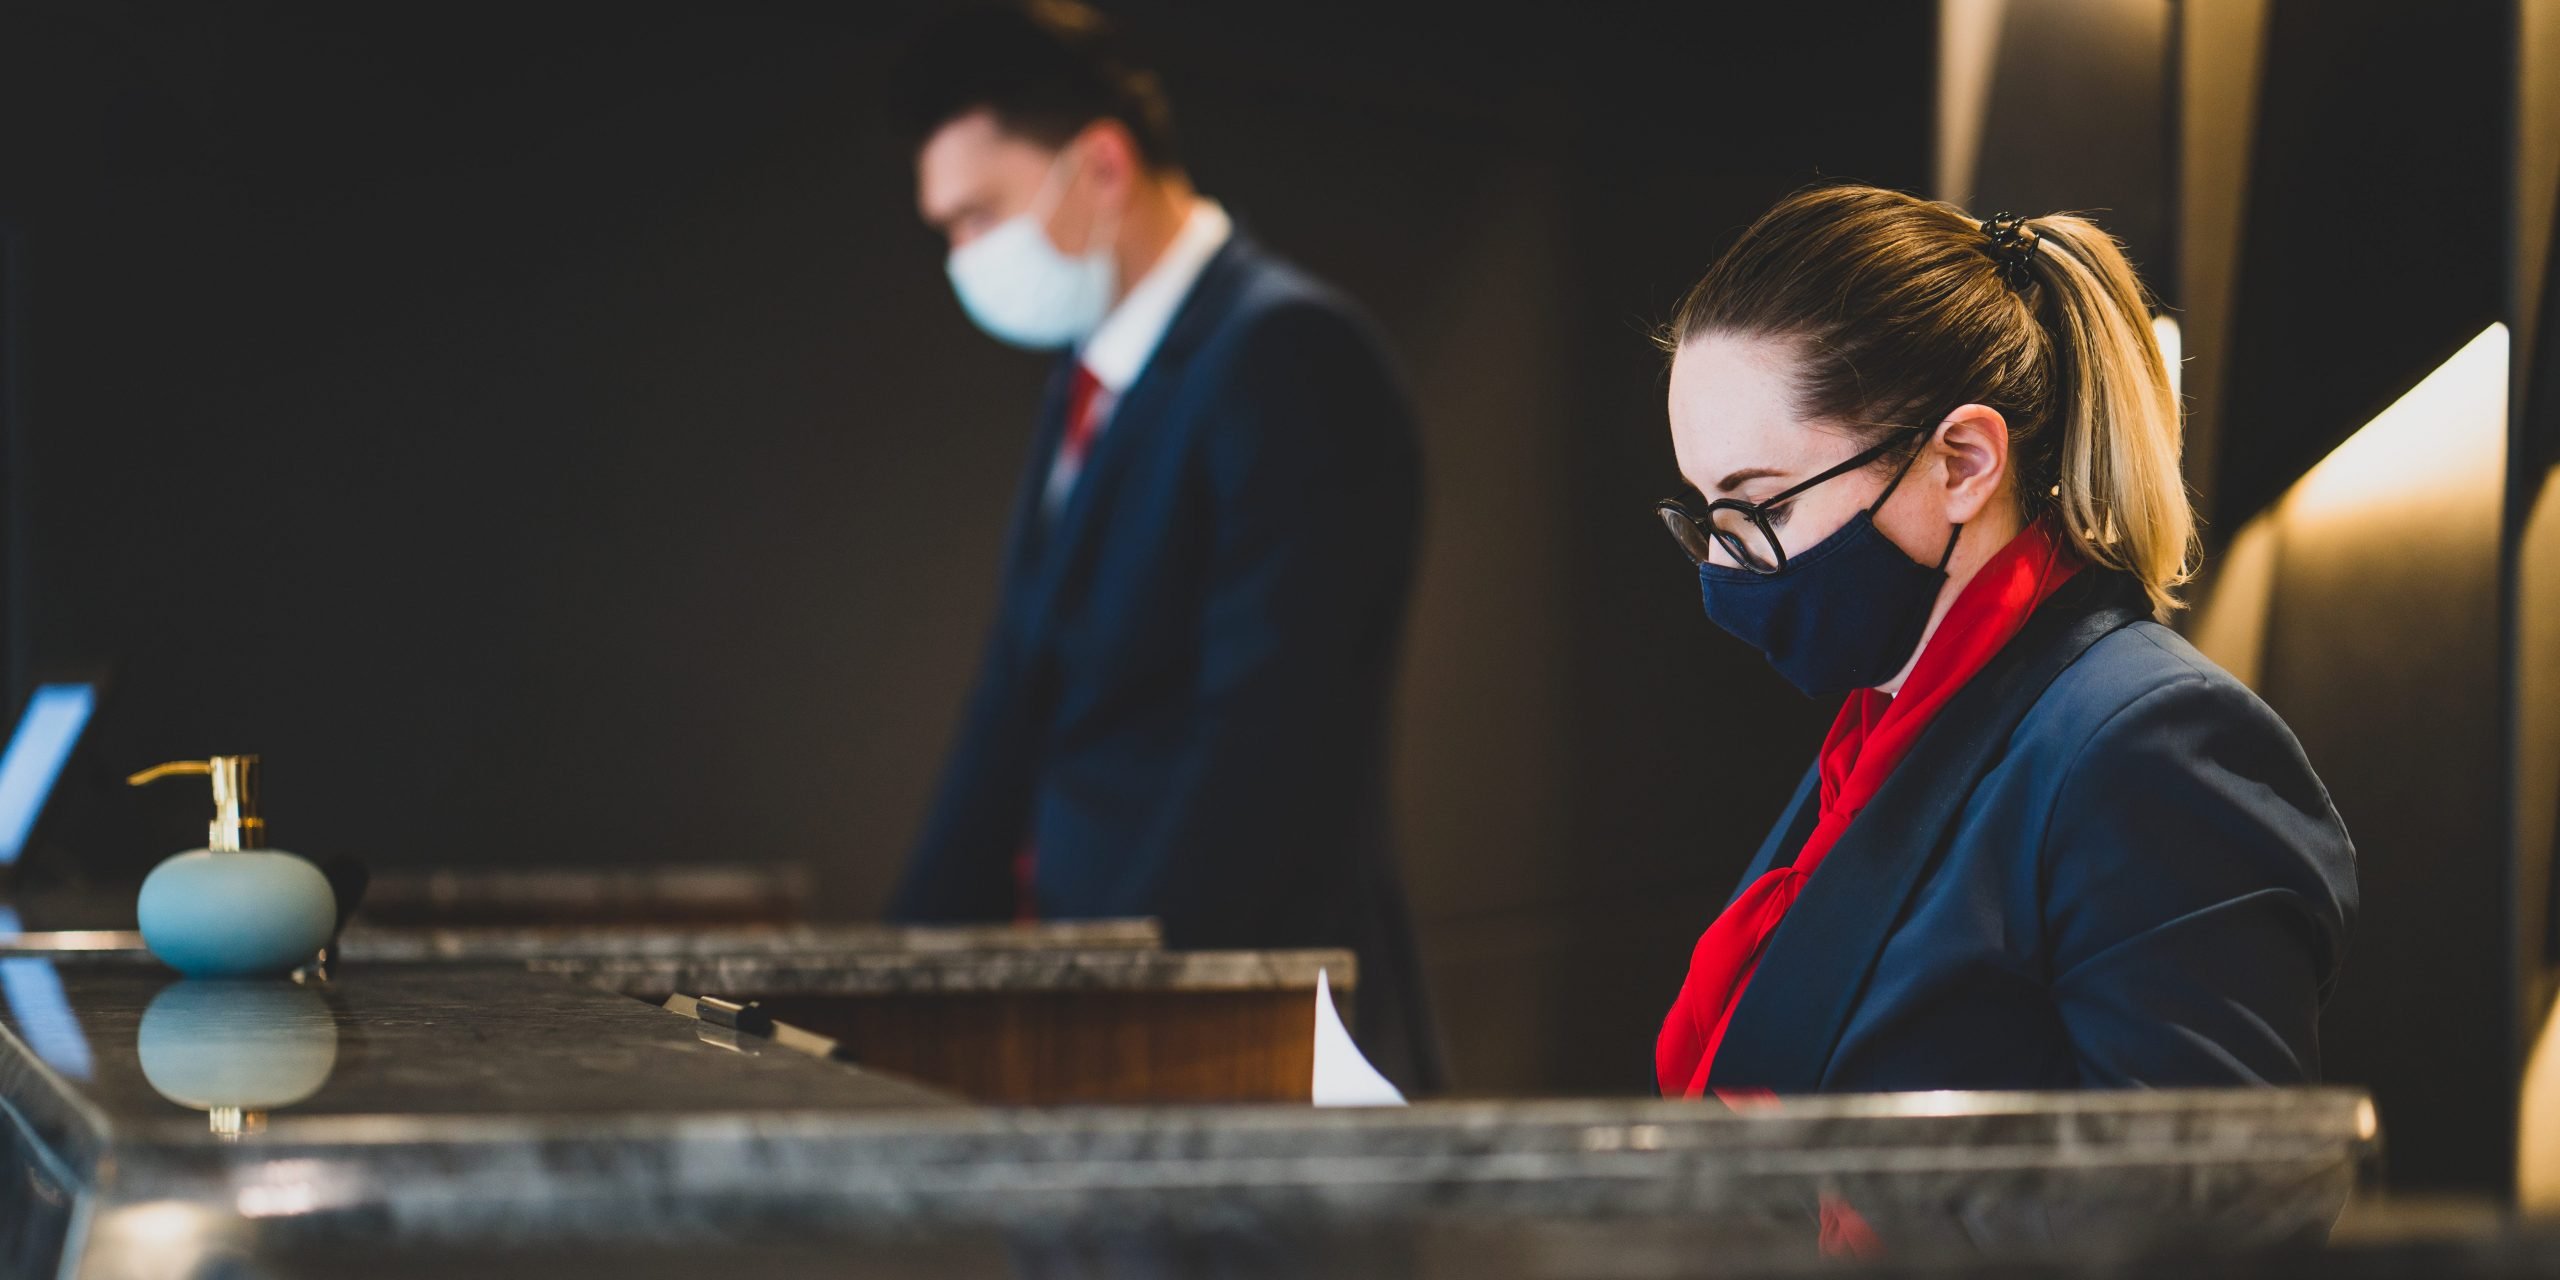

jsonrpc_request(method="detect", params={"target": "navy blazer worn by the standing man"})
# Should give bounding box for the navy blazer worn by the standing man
[891,236,1439,1088]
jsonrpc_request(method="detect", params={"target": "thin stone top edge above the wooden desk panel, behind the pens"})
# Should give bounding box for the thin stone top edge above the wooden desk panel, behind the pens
[530,950,1359,996]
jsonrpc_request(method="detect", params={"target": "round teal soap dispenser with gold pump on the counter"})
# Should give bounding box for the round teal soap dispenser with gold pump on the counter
[125,755,338,978]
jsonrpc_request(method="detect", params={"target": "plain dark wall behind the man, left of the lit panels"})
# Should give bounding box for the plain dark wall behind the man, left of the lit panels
[0,0,1933,1091]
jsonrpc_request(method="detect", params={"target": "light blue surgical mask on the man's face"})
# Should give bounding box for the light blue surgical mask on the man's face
[945,151,1119,351]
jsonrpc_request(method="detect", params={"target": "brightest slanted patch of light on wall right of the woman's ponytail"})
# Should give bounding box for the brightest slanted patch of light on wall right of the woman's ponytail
[2284,325,2506,522]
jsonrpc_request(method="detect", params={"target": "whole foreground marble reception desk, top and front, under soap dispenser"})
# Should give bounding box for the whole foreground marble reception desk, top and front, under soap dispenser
[0,955,2376,1280]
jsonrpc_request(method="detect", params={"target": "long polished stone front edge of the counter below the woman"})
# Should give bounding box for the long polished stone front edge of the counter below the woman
[49,1080,2363,1275]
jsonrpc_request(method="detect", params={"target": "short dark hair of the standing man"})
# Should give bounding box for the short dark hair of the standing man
[888,0,1178,169]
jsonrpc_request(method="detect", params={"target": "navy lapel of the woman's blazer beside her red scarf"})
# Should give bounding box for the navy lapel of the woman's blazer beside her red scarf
[1710,568,2150,1093]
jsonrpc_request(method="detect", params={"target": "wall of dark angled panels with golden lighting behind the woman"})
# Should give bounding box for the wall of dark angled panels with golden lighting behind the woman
[1938,0,2529,1190]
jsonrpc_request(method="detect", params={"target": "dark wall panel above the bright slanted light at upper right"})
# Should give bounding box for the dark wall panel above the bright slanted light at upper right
[2209,0,2514,525]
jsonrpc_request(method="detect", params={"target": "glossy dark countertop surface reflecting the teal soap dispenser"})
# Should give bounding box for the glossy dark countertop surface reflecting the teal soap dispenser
[0,957,960,1167]
